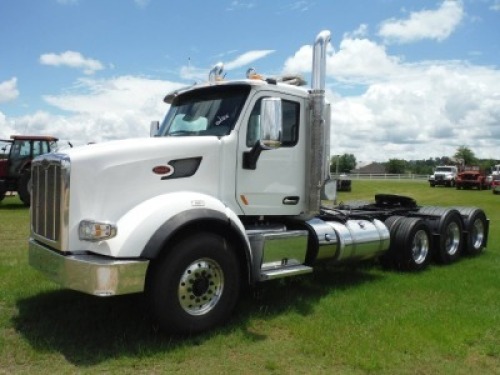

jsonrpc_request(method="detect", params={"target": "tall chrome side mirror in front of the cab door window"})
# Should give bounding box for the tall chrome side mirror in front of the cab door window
[260,98,283,150]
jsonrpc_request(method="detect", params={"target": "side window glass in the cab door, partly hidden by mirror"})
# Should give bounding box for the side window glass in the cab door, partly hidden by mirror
[247,98,300,147]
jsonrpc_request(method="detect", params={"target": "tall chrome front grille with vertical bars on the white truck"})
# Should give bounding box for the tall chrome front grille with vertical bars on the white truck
[31,154,69,250]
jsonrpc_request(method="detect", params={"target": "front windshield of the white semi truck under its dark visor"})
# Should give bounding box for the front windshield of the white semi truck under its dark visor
[158,85,250,136]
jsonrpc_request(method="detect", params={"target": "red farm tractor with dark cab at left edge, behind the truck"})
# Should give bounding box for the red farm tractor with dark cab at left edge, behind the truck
[0,135,58,206]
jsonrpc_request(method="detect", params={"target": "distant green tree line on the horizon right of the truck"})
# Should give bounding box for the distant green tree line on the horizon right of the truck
[330,146,500,175]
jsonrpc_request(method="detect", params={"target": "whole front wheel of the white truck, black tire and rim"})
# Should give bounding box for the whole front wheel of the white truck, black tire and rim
[146,233,240,333]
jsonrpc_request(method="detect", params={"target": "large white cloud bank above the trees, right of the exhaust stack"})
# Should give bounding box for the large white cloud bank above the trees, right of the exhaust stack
[326,62,500,161]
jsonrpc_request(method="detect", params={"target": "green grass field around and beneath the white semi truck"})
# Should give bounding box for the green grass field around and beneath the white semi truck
[0,181,500,375]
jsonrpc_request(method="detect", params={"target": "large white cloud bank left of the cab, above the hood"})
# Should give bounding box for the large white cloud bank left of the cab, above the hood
[0,76,183,145]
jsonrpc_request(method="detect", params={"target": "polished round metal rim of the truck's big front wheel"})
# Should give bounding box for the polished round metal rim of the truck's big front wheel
[178,258,224,315]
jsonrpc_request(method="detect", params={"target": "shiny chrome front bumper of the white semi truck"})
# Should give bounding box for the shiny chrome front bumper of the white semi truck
[29,239,149,297]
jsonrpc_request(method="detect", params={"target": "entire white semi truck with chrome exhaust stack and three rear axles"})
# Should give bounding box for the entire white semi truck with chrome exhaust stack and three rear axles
[29,31,489,333]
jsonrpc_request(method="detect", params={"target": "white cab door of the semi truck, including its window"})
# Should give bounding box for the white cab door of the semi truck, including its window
[236,91,306,215]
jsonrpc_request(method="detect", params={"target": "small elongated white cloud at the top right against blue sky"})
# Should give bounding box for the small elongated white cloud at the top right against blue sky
[379,0,465,43]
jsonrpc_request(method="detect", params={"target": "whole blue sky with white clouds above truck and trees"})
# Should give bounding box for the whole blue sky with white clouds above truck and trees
[0,0,500,164]
